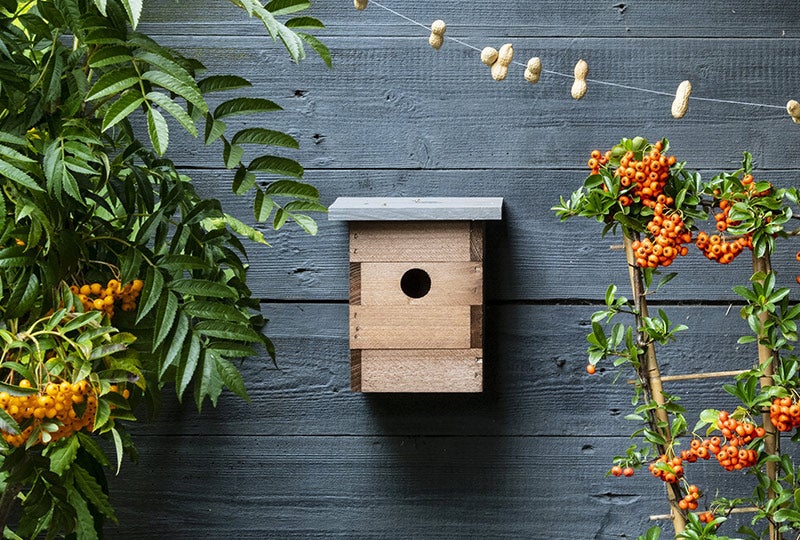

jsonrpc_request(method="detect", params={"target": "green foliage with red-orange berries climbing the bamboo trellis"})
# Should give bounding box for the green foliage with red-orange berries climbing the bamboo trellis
[553,138,800,540]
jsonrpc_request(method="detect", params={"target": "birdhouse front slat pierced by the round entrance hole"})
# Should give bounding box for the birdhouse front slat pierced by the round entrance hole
[358,262,483,306]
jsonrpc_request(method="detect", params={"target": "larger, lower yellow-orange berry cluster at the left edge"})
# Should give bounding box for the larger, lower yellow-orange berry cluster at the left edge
[0,379,97,447]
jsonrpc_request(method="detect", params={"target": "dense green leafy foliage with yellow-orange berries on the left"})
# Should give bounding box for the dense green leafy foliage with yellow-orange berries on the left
[0,0,330,538]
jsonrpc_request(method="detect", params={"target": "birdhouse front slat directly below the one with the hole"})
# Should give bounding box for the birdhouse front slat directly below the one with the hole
[350,306,472,349]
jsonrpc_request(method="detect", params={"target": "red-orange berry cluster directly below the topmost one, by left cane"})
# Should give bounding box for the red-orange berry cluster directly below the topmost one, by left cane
[632,205,692,268]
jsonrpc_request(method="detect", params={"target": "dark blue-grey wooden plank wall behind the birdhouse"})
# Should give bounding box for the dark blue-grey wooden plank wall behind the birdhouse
[108,0,800,540]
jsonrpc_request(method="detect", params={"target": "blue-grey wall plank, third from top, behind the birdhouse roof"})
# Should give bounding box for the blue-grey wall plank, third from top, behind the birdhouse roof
[192,168,800,303]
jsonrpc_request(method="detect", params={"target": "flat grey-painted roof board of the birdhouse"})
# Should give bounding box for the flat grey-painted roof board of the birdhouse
[328,197,503,221]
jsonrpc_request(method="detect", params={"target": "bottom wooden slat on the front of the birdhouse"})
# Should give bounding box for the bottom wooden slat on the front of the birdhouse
[359,349,483,392]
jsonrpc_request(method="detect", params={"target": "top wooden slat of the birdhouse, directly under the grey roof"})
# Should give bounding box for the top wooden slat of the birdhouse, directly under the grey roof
[350,221,473,262]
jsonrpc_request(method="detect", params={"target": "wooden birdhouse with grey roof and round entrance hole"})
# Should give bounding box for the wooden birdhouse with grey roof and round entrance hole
[328,197,503,392]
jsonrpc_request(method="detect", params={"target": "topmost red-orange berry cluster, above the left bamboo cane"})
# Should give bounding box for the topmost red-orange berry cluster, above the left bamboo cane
[614,141,677,208]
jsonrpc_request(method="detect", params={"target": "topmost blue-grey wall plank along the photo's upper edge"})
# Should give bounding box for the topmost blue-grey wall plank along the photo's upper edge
[142,0,798,38]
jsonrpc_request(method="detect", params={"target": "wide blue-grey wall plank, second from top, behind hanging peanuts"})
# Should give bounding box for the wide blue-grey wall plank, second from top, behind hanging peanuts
[123,36,800,170]
